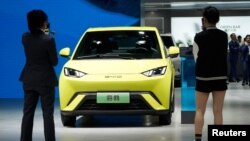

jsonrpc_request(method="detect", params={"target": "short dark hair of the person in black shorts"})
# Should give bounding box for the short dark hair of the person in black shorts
[203,6,220,24]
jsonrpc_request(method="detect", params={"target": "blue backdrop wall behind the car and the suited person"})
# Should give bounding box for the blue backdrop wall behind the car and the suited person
[0,0,140,98]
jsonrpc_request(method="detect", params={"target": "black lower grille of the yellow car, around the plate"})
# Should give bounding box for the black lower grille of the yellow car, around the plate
[77,95,152,110]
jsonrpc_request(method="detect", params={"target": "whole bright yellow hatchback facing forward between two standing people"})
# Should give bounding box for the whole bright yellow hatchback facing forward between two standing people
[59,27,179,126]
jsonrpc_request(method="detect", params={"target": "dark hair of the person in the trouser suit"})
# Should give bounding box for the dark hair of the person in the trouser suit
[27,10,48,34]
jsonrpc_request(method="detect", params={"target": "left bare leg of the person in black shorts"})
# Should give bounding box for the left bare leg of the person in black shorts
[194,91,209,134]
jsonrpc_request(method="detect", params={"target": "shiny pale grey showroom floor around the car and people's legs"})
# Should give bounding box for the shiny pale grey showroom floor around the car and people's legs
[0,83,250,141]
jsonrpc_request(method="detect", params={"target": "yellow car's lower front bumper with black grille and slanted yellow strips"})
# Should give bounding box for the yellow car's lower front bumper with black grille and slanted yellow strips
[61,92,169,116]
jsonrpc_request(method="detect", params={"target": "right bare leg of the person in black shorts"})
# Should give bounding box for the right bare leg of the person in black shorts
[212,91,226,124]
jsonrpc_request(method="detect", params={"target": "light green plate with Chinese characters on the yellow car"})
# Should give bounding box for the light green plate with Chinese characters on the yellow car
[96,92,130,104]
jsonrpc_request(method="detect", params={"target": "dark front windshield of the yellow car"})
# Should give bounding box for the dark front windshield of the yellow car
[73,30,161,59]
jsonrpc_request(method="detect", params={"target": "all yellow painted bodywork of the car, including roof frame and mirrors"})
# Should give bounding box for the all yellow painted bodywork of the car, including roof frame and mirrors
[59,27,176,111]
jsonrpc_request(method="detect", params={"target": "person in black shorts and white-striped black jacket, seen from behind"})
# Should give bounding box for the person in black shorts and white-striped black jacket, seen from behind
[193,6,228,141]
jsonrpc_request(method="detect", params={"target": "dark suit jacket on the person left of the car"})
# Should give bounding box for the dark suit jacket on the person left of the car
[19,31,58,87]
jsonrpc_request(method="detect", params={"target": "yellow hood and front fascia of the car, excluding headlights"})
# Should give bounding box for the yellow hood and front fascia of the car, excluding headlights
[59,59,174,109]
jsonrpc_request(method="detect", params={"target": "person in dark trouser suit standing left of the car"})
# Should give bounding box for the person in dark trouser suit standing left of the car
[19,10,58,141]
